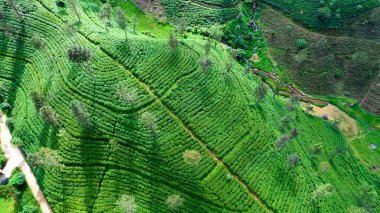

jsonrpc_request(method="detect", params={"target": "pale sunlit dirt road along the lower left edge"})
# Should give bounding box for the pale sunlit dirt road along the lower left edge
[0,111,53,213]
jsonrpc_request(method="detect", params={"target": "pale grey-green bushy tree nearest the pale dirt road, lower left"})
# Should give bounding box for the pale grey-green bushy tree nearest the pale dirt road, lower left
[28,147,63,169]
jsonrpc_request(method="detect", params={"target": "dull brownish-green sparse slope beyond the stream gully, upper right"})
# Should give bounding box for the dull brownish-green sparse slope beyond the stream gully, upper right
[261,7,380,112]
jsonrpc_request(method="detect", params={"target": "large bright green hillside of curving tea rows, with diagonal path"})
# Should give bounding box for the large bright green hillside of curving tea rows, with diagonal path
[0,0,380,212]
